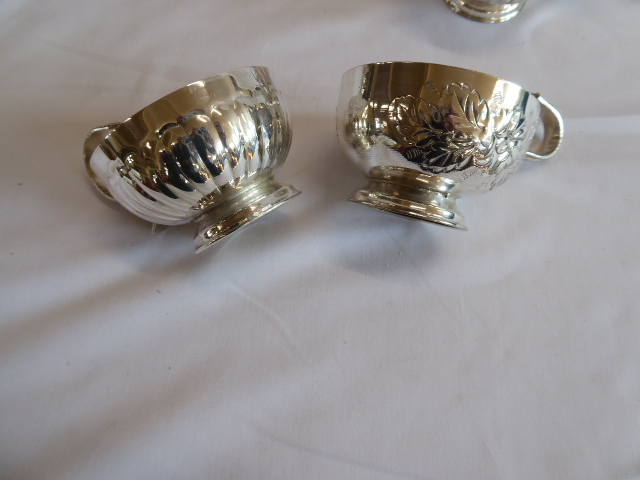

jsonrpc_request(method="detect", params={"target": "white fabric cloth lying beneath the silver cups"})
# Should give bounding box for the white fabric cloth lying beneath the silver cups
[0,0,640,480]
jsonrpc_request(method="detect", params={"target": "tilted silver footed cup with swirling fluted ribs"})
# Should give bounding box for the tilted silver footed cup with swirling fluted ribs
[84,67,300,252]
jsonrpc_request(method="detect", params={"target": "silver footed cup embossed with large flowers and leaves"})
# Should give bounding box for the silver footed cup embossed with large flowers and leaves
[337,62,563,229]
